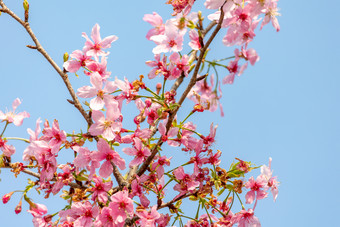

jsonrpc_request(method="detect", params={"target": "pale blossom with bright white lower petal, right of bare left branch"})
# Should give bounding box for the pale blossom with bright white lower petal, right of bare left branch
[77,72,116,110]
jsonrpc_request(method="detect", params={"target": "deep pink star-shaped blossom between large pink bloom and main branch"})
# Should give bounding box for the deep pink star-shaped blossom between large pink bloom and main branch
[123,138,151,167]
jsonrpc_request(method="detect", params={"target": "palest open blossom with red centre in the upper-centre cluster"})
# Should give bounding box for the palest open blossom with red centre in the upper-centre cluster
[150,20,183,54]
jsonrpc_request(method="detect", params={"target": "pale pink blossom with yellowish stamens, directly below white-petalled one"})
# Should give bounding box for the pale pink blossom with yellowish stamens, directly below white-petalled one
[89,100,122,141]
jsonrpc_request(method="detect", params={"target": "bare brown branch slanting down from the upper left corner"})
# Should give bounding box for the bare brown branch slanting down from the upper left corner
[0,0,93,126]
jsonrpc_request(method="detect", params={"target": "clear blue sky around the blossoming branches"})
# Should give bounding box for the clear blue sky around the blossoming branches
[0,0,340,227]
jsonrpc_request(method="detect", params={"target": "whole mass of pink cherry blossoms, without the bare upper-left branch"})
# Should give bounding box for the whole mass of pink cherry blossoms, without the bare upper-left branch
[0,0,280,227]
